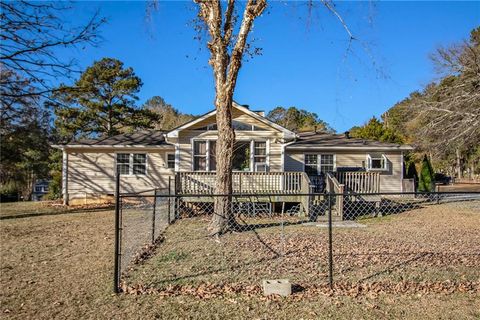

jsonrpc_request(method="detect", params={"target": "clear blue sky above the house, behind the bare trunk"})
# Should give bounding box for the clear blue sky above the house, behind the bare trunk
[58,1,480,132]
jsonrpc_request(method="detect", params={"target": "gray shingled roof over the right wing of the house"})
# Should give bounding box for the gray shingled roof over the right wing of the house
[286,132,412,150]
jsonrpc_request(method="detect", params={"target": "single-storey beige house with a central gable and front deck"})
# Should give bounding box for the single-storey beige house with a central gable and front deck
[51,103,412,208]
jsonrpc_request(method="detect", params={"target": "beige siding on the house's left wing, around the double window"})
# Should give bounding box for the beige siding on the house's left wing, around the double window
[68,147,174,202]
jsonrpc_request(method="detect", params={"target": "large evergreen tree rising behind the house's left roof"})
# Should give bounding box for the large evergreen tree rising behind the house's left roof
[53,58,159,140]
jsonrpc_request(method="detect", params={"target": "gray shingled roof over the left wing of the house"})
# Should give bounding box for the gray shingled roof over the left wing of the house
[63,130,167,147]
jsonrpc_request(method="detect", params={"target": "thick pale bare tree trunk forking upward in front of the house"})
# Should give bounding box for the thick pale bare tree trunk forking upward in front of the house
[196,0,267,235]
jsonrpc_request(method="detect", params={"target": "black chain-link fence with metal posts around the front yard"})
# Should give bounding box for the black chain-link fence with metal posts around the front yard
[115,190,480,292]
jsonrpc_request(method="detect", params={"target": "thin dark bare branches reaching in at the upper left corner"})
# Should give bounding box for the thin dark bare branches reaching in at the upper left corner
[0,1,105,97]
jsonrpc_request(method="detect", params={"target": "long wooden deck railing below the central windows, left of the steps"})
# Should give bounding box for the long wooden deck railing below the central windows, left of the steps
[176,171,311,194]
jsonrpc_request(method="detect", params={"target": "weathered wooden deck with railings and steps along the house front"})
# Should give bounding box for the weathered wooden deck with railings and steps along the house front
[175,171,380,218]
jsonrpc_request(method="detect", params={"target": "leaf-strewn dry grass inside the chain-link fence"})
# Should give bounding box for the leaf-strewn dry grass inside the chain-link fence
[126,203,480,289]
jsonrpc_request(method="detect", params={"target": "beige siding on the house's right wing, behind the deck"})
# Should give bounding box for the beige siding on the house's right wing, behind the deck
[285,149,402,192]
